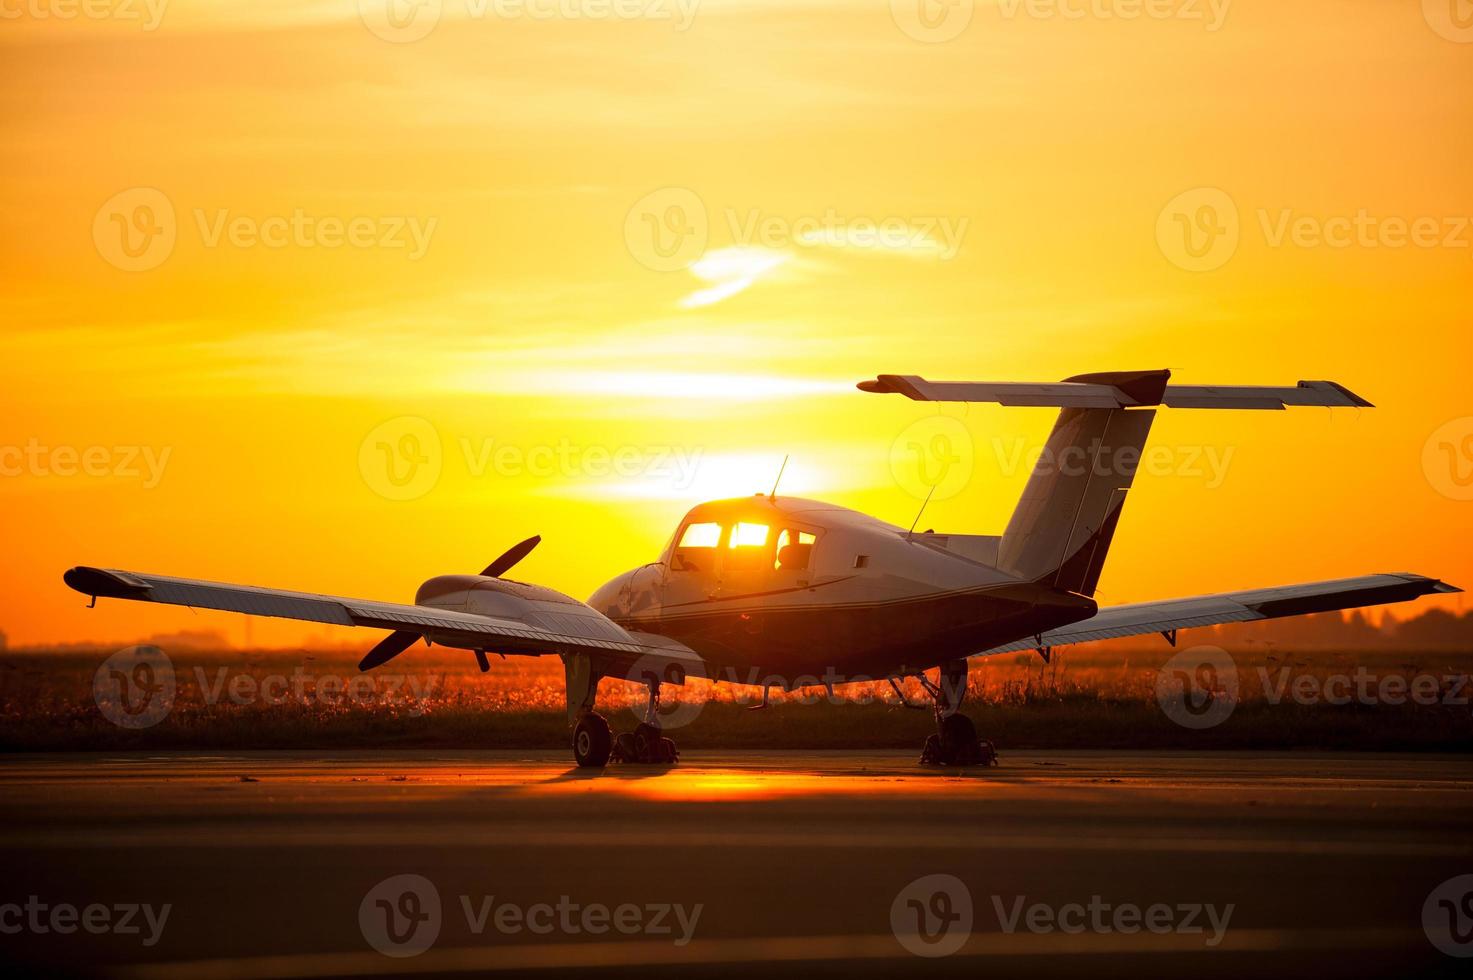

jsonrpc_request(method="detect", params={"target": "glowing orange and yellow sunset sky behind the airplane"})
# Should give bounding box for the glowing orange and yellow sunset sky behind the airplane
[0,0,1473,645]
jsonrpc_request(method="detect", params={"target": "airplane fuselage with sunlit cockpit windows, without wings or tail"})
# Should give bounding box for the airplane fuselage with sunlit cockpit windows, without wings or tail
[589,497,1096,685]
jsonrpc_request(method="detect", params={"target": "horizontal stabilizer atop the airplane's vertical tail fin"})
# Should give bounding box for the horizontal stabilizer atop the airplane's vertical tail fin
[859,373,1373,410]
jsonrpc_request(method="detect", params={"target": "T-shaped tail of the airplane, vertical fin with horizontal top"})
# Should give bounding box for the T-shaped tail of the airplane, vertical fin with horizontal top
[859,370,1371,595]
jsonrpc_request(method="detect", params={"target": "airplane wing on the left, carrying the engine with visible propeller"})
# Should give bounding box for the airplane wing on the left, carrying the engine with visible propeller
[63,566,706,676]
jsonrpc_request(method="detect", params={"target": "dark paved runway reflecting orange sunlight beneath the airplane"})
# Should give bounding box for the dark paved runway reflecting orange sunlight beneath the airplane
[0,752,1473,977]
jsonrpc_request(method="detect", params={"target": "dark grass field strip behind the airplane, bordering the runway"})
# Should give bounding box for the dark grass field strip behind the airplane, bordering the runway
[0,644,1473,753]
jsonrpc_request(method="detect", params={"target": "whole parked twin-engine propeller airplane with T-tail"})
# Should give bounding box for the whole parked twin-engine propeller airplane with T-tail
[63,370,1461,768]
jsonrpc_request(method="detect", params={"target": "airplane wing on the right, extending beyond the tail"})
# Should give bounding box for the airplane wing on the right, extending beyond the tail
[980,572,1463,656]
